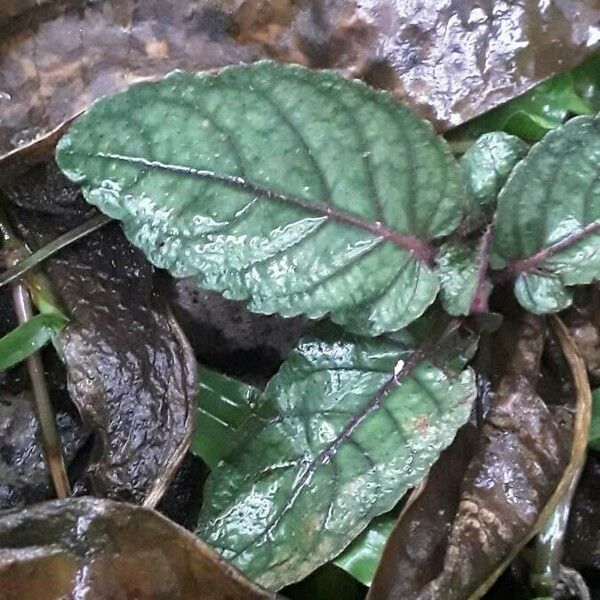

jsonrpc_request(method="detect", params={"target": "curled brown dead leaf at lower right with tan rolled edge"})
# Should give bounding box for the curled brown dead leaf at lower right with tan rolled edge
[368,315,591,600]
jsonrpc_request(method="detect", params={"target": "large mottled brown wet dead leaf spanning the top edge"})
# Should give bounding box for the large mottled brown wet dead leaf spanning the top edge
[0,0,600,168]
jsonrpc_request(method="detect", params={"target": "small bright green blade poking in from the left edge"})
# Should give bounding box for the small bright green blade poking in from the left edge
[0,313,68,371]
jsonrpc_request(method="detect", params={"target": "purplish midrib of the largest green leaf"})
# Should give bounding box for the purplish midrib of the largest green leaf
[91,152,436,266]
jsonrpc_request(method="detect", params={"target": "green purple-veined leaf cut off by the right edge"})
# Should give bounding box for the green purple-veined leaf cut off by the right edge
[490,116,600,313]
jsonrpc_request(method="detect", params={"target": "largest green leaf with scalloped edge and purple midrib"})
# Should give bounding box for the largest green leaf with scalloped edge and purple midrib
[56,62,466,335]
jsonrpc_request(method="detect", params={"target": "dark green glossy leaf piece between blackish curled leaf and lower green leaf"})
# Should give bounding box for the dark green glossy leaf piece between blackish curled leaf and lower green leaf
[190,365,266,469]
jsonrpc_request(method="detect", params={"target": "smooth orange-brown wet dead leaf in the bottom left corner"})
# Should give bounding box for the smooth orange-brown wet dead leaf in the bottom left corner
[0,498,275,600]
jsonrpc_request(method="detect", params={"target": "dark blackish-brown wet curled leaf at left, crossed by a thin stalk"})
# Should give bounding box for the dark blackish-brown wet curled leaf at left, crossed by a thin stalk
[7,167,196,506]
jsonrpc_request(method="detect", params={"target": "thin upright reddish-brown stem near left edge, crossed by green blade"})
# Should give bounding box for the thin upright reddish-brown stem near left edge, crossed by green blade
[0,213,71,498]
